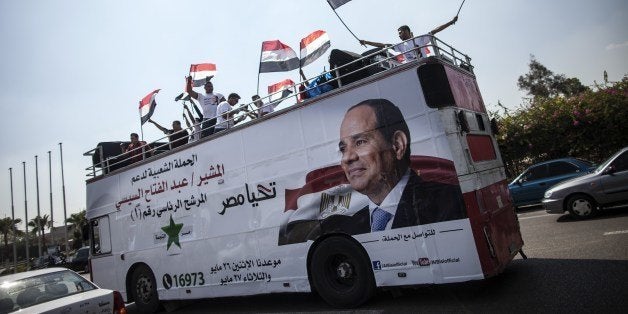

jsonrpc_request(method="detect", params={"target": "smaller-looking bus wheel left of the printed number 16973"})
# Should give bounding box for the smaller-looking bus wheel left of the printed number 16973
[131,265,159,313]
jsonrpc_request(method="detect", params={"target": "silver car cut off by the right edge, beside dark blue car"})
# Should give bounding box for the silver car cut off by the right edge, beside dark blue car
[541,147,628,218]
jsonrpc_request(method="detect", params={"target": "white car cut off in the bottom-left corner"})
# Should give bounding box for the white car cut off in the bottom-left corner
[0,268,126,314]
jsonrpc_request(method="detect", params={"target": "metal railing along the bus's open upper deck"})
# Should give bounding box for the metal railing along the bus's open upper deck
[83,35,473,178]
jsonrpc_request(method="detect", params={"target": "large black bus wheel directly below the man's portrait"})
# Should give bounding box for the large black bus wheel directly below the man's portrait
[310,237,375,308]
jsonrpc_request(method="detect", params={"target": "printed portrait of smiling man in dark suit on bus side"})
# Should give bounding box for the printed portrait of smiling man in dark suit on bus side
[279,99,466,244]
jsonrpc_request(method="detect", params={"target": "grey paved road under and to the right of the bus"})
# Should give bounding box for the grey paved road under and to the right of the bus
[129,208,628,314]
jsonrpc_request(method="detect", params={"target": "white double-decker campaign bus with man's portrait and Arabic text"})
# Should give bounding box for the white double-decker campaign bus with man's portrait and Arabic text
[86,37,523,312]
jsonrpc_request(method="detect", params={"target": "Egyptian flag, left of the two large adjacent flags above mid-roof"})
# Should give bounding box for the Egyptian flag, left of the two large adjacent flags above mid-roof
[259,40,299,73]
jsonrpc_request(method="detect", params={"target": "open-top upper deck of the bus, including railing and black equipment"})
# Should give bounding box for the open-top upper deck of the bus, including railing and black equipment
[83,35,473,183]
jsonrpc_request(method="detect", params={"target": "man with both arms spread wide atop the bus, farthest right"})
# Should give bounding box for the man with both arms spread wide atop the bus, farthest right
[360,16,458,62]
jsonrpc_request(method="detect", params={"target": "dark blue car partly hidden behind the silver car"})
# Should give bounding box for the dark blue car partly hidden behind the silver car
[508,158,594,207]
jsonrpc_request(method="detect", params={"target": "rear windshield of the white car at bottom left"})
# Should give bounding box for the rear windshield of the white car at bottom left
[0,270,97,313]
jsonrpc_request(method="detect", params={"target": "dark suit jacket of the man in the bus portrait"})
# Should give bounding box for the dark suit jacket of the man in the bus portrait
[279,171,467,245]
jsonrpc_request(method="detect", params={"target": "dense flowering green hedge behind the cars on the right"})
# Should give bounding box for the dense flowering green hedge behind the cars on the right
[493,76,628,177]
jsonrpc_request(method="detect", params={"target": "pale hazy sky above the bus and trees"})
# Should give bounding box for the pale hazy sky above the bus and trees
[0,0,628,229]
